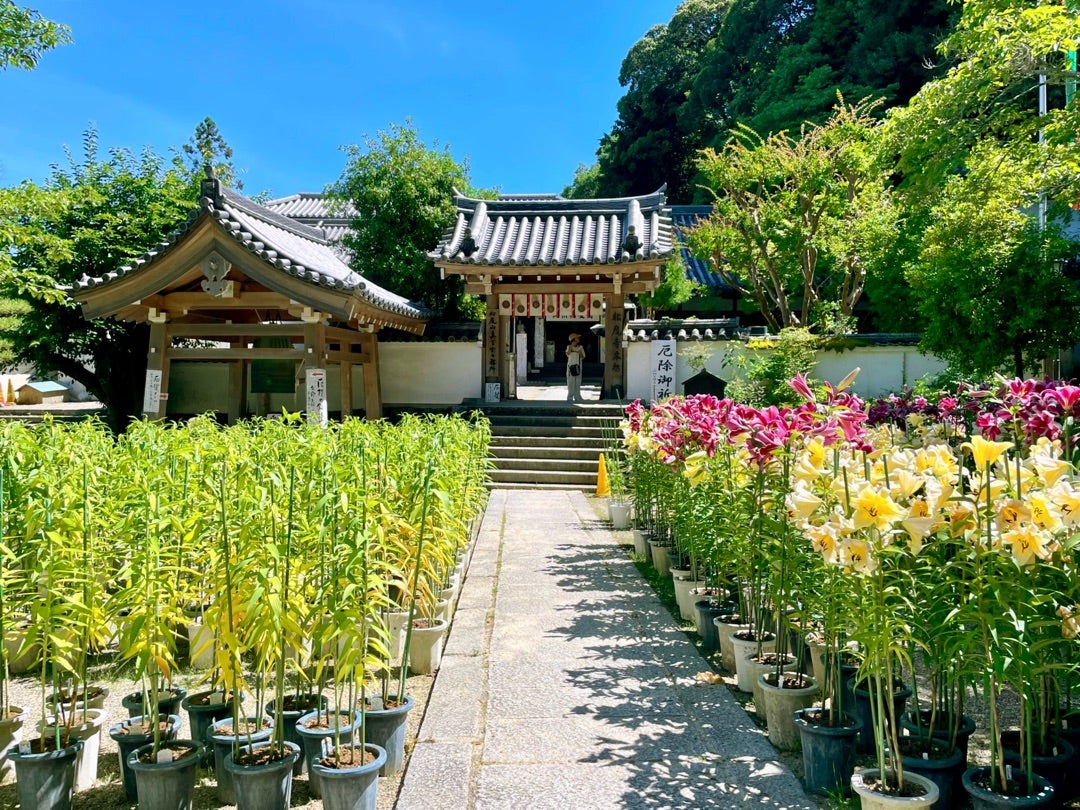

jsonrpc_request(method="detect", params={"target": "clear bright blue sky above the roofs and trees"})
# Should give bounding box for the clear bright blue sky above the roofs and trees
[0,0,678,197]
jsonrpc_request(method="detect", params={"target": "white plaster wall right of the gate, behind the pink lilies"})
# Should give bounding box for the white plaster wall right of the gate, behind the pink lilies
[626,340,946,400]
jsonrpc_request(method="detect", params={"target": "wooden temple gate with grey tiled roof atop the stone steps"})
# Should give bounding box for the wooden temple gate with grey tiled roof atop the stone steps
[429,188,673,397]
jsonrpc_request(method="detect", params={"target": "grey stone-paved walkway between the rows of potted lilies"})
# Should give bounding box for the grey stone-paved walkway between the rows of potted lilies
[396,489,815,810]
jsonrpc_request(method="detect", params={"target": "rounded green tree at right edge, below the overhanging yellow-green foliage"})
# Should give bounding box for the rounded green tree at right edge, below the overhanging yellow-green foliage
[908,143,1080,377]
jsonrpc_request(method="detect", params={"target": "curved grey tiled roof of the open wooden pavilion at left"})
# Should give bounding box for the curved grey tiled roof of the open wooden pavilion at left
[73,179,431,320]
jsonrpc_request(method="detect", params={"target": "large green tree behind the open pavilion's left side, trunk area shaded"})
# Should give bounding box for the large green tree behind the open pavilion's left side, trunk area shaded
[0,131,198,429]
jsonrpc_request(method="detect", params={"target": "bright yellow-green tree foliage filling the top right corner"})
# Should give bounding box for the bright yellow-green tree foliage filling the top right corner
[885,0,1080,203]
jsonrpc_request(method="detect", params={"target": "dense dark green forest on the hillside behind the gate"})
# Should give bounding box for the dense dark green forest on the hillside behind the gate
[568,0,961,203]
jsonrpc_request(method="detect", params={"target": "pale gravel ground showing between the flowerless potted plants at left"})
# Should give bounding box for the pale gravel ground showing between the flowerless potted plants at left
[0,663,434,810]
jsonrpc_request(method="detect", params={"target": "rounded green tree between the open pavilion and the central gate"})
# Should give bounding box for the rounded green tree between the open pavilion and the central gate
[329,121,490,320]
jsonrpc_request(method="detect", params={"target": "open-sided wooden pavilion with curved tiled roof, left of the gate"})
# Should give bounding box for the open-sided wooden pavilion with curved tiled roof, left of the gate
[71,173,430,422]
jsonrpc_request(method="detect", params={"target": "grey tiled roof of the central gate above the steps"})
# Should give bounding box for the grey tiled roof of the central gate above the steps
[428,189,672,266]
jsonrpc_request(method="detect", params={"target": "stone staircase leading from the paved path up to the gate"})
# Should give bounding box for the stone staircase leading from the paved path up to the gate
[470,402,623,490]
